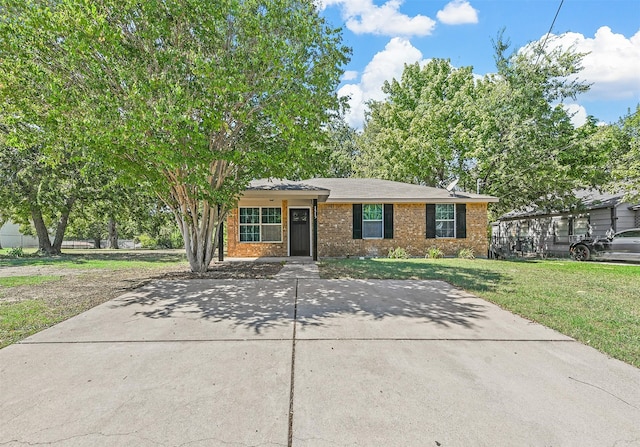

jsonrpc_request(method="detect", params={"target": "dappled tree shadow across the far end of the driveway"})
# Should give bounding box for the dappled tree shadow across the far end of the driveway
[111,279,486,335]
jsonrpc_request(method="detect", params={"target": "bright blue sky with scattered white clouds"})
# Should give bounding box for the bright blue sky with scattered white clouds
[317,0,640,129]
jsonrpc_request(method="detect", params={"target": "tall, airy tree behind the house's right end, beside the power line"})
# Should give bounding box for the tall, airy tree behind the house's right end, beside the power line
[467,35,601,215]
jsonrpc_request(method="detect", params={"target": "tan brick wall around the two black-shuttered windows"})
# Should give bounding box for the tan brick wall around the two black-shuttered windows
[318,203,488,258]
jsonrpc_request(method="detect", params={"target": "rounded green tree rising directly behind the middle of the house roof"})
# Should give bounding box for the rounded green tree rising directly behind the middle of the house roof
[356,59,474,186]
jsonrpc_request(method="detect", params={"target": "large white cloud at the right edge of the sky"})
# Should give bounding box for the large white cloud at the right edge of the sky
[528,26,640,100]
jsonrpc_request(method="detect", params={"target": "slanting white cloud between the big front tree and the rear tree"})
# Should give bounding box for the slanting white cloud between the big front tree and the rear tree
[338,37,423,129]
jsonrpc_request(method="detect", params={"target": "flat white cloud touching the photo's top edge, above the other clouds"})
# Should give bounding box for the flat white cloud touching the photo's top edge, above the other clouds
[319,0,436,36]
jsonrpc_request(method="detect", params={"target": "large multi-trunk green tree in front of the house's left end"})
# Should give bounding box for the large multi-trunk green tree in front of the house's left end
[0,0,348,272]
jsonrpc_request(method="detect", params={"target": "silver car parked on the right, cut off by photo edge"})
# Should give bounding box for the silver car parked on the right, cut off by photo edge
[569,228,640,261]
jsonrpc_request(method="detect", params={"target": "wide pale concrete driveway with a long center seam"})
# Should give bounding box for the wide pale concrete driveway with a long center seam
[0,278,640,446]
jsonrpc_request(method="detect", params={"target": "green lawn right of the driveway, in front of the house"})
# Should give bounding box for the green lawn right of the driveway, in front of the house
[320,259,640,367]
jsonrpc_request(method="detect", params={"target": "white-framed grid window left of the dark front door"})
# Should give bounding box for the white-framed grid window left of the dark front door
[240,207,282,242]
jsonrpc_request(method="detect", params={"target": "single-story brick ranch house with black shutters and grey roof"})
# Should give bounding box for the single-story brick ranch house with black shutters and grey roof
[227,178,498,259]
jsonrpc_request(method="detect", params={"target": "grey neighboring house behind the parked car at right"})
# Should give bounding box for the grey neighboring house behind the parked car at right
[491,190,640,256]
